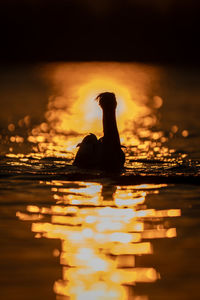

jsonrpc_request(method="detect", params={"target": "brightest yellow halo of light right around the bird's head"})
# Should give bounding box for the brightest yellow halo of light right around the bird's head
[65,76,139,133]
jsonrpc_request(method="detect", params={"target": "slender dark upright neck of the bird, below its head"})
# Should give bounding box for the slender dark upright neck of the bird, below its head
[103,109,120,145]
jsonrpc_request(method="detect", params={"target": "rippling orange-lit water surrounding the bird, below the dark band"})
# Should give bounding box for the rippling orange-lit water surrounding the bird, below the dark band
[0,63,200,300]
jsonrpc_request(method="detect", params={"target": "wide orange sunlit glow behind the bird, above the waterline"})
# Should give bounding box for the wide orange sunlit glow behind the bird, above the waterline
[25,63,163,158]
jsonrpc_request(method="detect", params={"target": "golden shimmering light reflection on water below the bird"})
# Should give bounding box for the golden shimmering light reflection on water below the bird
[17,181,181,300]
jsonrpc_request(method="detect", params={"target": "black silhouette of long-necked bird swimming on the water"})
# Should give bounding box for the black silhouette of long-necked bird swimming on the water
[73,92,125,170]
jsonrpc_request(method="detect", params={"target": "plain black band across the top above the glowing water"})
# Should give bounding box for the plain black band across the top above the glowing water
[0,0,200,64]
